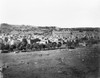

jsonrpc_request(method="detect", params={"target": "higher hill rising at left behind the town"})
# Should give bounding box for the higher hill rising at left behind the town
[0,23,55,34]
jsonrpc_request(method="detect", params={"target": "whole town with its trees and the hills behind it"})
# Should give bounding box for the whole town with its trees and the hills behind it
[0,23,100,53]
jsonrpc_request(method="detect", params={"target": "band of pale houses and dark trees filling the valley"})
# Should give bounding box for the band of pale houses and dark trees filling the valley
[0,31,100,52]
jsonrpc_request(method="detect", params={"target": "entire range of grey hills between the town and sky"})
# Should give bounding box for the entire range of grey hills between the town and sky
[0,23,100,38]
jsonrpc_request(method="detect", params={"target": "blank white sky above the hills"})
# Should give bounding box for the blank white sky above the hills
[0,0,100,28]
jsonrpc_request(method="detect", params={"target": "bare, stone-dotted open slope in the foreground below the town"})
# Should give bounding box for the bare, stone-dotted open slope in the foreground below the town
[0,45,100,78]
